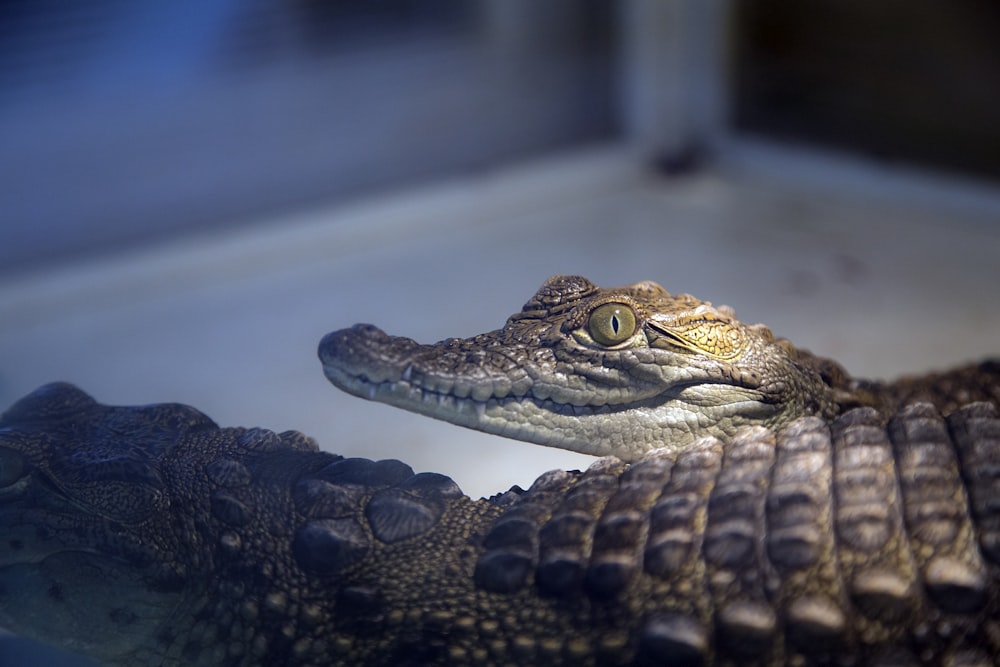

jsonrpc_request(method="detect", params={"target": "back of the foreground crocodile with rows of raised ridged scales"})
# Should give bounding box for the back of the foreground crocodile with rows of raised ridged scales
[476,403,1000,665]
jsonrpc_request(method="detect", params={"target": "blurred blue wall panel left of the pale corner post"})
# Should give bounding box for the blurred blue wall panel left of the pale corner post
[0,0,613,274]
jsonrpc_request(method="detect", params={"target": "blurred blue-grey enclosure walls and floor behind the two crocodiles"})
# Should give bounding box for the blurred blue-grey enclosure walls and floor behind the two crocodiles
[0,0,1000,665]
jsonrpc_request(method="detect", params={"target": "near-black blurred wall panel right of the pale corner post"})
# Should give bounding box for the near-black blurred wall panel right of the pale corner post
[734,0,1000,179]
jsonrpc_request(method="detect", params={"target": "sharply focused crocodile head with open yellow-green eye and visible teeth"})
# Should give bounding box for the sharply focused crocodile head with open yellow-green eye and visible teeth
[319,276,846,460]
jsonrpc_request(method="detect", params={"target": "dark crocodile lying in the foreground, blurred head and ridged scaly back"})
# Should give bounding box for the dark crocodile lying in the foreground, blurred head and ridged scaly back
[0,385,1000,666]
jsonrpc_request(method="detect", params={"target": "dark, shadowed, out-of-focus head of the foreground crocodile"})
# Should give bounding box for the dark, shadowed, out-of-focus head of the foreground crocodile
[0,384,214,661]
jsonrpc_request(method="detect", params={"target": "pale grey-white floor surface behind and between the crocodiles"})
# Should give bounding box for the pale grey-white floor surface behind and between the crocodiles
[0,147,1000,496]
